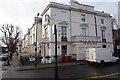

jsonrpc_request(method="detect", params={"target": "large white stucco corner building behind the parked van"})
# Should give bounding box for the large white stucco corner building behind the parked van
[41,0,113,60]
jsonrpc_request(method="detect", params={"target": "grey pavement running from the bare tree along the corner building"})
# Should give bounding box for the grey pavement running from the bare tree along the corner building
[3,54,87,71]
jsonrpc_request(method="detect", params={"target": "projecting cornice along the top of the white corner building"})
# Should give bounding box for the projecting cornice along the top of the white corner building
[41,2,112,18]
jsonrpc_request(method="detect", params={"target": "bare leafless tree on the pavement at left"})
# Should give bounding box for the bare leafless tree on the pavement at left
[0,24,21,65]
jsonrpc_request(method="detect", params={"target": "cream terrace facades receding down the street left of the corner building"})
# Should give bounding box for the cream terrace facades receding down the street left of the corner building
[22,17,42,55]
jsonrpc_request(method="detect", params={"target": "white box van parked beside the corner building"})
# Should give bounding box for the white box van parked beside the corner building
[85,48,119,65]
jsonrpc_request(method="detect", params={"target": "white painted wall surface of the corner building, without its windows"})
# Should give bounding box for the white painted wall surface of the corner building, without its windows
[42,1,113,59]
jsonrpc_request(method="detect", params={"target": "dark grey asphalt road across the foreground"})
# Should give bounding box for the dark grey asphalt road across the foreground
[2,64,120,80]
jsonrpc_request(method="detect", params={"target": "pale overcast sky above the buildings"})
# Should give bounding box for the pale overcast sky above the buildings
[0,0,119,34]
